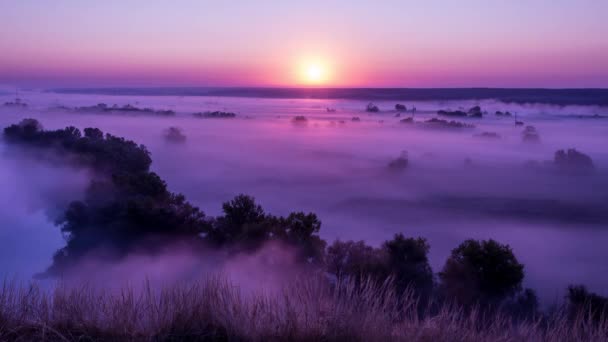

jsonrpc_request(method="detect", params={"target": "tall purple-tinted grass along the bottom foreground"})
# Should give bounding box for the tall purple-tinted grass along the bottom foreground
[0,276,608,341]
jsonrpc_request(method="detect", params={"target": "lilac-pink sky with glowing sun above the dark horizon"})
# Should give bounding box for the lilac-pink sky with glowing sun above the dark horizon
[0,0,608,88]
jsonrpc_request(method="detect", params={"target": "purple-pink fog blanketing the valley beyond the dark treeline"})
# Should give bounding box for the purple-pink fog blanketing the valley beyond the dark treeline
[0,91,608,301]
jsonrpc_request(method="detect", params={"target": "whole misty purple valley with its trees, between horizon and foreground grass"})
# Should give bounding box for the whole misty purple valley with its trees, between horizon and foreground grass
[0,90,608,336]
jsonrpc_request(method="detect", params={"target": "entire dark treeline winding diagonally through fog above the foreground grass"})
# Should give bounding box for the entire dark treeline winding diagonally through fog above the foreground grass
[4,119,608,320]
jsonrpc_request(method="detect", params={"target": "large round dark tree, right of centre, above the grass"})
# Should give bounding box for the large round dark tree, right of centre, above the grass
[439,240,524,305]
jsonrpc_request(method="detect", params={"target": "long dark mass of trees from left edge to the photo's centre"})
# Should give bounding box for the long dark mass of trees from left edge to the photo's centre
[4,119,325,275]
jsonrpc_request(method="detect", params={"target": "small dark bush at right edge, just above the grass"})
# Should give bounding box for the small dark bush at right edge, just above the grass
[566,285,608,321]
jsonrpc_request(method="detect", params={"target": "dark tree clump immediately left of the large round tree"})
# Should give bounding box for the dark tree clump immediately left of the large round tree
[326,234,433,297]
